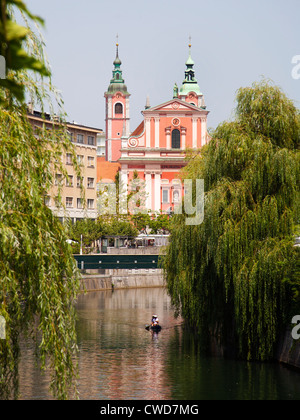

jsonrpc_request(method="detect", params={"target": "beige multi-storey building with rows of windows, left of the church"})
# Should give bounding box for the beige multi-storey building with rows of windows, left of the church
[28,111,102,222]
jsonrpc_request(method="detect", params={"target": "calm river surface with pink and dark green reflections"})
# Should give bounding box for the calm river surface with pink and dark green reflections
[20,288,300,400]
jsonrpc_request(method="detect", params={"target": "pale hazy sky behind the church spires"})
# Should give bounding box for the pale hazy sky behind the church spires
[25,0,300,131]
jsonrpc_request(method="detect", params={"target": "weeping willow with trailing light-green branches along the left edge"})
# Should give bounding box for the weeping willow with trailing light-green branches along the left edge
[0,0,80,399]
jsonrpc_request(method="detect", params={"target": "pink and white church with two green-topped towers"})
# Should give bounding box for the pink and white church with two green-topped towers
[105,41,209,213]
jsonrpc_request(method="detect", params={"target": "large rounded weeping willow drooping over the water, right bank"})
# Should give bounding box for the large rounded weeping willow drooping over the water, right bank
[165,81,300,360]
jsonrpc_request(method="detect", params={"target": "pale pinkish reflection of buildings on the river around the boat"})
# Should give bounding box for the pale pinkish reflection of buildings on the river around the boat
[78,288,181,399]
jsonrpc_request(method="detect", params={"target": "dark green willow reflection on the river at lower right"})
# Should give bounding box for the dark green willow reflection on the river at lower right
[165,327,300,400]
